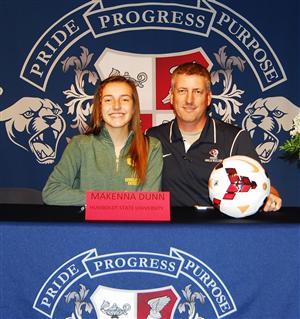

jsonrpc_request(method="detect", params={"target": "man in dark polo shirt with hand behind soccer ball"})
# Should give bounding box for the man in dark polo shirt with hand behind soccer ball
[147,62,282,211]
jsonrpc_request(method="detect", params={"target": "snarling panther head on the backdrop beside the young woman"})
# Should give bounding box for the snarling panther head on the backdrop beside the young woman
[0,97,66,164]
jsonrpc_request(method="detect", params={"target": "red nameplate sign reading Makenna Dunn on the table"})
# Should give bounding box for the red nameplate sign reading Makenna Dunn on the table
[85,191,170,221]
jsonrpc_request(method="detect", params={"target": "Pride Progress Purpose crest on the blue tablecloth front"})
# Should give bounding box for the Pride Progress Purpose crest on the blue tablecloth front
[33,247,237,319]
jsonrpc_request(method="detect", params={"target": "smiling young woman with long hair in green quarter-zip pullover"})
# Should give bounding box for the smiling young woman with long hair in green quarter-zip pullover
[43,76,162,205]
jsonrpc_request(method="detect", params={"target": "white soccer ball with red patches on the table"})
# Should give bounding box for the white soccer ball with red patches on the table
[208,155,270,218]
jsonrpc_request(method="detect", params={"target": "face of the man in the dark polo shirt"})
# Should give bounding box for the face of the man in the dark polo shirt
[171,74,211,130]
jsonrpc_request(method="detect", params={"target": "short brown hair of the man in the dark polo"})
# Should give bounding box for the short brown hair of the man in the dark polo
[171,62,211,91]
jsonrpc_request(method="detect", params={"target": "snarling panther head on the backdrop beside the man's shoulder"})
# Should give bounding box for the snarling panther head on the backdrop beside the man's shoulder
[243,96,299,163]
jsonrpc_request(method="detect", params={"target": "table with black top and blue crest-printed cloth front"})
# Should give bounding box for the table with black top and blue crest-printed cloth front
[0,205,300,319]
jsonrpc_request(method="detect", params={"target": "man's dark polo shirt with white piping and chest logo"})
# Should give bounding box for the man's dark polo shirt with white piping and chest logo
[147,118,259,207]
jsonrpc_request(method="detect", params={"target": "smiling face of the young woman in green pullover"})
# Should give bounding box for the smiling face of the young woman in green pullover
[101,82,134,130]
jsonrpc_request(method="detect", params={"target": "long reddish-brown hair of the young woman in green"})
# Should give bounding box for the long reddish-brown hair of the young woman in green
[85,75,149,184]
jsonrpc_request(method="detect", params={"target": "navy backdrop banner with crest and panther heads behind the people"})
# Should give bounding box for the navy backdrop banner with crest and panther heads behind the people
[0,0,300,206]
